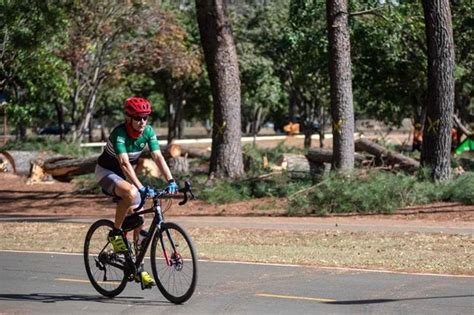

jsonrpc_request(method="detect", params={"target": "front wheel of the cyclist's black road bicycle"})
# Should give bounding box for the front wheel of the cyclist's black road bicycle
[150,222,197,304]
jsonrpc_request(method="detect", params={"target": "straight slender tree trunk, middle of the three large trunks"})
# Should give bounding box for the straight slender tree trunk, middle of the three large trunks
[326,0,354,170]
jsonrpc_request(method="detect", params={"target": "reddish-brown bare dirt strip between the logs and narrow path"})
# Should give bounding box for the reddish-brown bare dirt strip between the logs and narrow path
[0,173,474,224]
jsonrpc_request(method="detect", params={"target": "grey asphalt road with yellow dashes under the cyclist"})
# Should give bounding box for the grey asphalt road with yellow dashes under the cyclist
[0,251,474,314]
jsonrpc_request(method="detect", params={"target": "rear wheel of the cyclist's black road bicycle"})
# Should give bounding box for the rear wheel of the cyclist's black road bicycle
[84,220,127,297]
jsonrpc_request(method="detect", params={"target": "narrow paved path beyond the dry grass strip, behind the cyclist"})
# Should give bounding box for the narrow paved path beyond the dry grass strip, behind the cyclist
[0,214,474,235]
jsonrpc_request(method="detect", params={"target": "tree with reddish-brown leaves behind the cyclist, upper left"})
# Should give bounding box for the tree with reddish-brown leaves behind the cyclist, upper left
[61,0,146,141]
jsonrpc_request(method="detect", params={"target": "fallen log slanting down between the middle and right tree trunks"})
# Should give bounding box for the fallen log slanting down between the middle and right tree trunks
[355,139,420,171]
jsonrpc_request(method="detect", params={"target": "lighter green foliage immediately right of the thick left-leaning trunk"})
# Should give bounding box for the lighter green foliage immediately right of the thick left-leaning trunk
[231,5,287,134]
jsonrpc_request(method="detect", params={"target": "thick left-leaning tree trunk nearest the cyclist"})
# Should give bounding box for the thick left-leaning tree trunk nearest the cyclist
[196,0,244,179]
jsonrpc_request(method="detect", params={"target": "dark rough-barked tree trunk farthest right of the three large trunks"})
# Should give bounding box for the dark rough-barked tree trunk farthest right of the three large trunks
[421,0,454,180]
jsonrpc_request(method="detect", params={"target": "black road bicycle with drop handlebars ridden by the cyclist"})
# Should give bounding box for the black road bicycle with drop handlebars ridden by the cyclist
[84,181,197,304]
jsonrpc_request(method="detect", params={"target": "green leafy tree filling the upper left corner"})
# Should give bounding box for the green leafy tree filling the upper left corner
[0,0,67,138]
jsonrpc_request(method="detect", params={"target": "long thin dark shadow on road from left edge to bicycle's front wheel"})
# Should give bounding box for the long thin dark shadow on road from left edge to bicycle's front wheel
[0,293,172,306]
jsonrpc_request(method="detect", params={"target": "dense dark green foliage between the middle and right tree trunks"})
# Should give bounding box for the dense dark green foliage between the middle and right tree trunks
[350,1,427,125]
